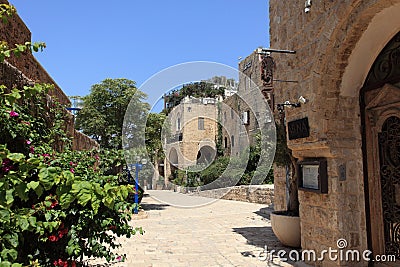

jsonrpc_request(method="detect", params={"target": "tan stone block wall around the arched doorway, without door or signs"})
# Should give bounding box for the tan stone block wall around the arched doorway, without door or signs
[270,0,400,266]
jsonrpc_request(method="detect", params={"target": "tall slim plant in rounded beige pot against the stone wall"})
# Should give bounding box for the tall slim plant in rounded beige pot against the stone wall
[271,114,301,247]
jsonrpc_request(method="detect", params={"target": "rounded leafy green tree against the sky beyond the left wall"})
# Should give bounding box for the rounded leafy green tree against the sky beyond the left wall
[76,79,150,149]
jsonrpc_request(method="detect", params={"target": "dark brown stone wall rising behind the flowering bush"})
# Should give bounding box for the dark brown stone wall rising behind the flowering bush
[0,0,98,150]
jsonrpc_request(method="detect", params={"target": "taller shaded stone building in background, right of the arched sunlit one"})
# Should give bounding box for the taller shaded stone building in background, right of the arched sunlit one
[221,50,273,156]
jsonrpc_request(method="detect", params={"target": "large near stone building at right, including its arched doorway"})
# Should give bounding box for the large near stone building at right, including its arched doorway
[270,0,400,266]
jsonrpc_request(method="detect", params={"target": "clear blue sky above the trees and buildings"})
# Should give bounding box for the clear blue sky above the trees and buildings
[9,0,269,105]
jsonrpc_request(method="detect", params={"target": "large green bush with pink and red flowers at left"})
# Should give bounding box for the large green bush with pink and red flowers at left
[0,84,142,266]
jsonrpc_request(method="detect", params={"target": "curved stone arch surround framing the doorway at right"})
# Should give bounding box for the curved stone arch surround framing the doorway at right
[318,0,400,260]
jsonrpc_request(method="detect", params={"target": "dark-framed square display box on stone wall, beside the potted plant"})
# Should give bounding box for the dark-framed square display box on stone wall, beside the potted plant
[298,158,328,194]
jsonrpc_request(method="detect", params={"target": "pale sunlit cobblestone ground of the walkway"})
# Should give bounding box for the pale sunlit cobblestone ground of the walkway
[86,191,291,267]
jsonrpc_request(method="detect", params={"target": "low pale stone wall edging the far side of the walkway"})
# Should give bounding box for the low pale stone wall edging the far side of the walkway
[190,185,274,205]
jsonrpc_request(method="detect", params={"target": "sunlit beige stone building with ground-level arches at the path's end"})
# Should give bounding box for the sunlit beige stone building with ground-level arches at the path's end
[164,96,220,184]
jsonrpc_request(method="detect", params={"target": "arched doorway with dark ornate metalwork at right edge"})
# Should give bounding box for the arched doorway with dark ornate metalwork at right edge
[360,30,400,259]
